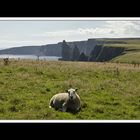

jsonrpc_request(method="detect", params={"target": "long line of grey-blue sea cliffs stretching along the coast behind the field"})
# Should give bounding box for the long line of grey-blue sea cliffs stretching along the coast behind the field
[0,39,127,61]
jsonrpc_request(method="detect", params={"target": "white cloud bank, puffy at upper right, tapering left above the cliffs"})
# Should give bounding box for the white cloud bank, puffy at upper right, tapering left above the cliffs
[33,21,140,39]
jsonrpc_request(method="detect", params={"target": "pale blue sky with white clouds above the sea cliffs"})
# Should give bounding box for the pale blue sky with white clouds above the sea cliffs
[0,20,140,49]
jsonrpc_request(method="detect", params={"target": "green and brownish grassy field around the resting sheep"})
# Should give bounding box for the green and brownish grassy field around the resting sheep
[0,60,140,120]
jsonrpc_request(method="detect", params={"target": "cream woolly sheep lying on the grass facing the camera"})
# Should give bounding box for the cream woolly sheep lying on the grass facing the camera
[49,88,81,113]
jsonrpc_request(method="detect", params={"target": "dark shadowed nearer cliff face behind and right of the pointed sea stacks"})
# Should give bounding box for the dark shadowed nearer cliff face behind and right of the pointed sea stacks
[62,39,124,62]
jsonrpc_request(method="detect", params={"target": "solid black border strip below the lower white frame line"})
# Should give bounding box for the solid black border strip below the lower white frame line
[0,123,140,136]
